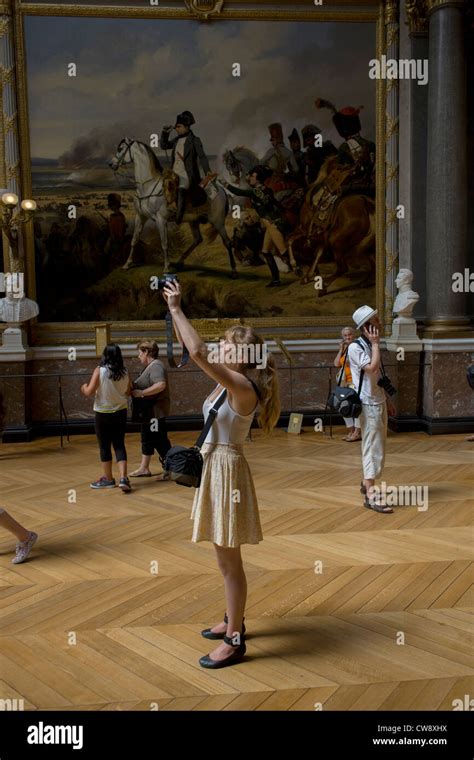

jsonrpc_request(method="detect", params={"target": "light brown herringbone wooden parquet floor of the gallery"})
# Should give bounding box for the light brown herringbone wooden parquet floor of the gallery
[0,429,474,710]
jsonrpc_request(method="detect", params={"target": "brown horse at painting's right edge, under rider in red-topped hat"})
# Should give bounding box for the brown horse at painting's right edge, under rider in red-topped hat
[288,156,375,296]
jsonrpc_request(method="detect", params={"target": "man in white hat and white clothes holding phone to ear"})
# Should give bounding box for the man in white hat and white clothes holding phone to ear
[347,306,395,514]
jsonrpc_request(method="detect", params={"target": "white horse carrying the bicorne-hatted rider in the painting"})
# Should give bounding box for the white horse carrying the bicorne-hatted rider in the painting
[109,137,237,277]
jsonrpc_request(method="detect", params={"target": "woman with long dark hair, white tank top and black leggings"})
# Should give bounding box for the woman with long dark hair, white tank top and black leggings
[81,343,131,492]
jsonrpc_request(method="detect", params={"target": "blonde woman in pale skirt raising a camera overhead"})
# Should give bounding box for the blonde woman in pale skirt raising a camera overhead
[163,281,280,668]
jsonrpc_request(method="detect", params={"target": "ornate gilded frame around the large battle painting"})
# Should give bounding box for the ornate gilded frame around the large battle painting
[9,0,390,345]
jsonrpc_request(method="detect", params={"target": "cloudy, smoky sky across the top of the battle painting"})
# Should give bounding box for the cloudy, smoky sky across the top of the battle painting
[25,17,375,161]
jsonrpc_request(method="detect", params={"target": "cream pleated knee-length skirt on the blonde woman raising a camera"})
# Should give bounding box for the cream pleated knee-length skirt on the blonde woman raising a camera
[191,443,263,548]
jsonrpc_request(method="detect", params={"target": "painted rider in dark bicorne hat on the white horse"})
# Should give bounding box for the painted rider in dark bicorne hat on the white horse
[160,111,211,224]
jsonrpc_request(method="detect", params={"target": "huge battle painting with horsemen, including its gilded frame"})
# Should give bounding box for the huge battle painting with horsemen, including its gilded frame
[13,2,385,342]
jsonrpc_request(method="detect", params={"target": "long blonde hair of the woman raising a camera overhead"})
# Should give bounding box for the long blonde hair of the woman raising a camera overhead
[226,325,281,434]
